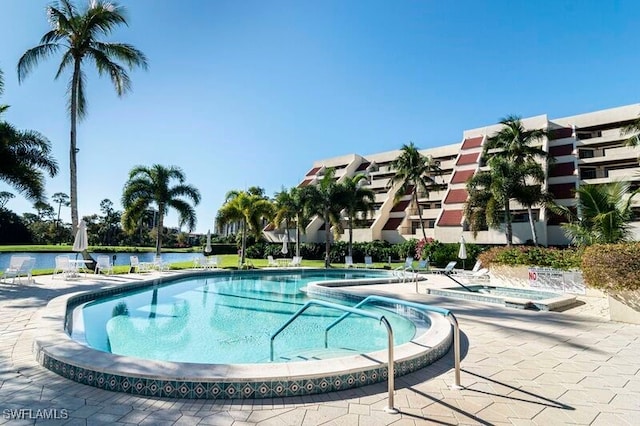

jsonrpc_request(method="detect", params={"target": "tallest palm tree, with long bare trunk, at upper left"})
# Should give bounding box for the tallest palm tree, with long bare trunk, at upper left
[18,0,147,230]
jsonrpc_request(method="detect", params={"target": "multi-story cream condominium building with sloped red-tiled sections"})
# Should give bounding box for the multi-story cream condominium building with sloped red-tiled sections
[266,104,640,245]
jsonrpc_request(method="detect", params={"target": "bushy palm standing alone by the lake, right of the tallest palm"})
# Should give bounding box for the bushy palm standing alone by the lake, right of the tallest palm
[122,164,200,256]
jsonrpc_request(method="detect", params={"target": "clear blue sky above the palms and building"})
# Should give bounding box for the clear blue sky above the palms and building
[0,0,640,232]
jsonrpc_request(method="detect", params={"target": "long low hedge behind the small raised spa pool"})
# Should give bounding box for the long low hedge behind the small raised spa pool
[478,246,582,270]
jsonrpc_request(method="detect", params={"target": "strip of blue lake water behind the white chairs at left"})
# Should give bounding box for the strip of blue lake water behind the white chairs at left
[0,252,204,271]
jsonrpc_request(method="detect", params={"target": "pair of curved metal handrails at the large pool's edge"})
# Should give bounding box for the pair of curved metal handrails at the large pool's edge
[269,296,462,414]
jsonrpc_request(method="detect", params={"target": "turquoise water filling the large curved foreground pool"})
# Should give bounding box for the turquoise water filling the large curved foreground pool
[71,271,416,364]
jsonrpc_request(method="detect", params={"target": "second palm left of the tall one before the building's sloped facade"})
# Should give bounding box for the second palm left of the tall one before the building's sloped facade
[302,168,344,268]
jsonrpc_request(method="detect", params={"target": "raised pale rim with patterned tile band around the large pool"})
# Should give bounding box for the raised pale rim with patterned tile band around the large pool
[33,269,453,399]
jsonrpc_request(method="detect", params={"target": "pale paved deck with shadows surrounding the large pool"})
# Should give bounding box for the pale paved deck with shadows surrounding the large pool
[0,272,640,426]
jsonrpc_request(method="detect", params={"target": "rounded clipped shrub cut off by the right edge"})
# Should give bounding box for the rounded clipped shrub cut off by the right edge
[582,242,640,290]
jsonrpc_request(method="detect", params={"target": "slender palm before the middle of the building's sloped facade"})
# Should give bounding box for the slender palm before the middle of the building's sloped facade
[389,142,443,240]
